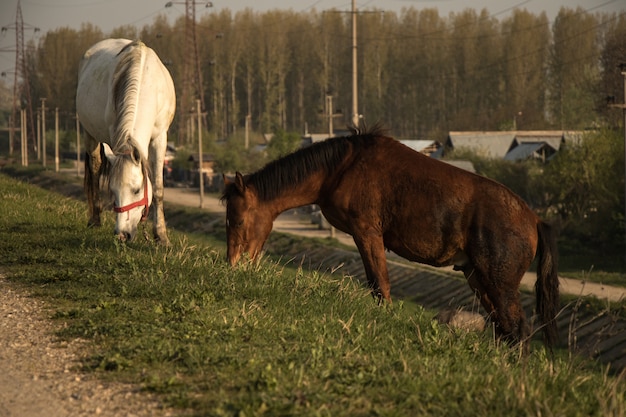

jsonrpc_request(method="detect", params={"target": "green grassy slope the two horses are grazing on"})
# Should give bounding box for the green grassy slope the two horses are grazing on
[0,174,626,416]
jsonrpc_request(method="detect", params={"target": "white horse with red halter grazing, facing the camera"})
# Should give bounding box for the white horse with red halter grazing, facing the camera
[76,39,176,244]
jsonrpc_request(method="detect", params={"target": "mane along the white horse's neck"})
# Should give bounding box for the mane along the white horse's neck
[111,41,146,153]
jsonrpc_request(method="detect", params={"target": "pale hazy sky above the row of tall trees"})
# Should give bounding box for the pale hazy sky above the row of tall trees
[0,0,626,73]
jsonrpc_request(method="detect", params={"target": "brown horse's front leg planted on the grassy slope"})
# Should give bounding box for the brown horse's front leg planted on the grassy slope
[354,233,391,302]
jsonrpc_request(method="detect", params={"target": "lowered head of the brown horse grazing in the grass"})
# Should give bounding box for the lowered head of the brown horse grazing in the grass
[221,172,274,266]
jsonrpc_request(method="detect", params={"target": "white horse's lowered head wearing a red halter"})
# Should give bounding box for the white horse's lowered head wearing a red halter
[102,144,152,241]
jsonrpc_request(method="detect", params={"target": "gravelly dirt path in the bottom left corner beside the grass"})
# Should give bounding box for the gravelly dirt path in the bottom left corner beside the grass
[0,275,173,417]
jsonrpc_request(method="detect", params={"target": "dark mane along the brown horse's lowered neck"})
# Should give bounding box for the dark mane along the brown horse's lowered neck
[221,125,385,201]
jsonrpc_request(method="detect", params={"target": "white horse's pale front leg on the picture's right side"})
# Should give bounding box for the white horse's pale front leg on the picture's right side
[150,132,170,245]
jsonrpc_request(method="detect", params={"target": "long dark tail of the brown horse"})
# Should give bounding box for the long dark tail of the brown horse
[535,222,560,348]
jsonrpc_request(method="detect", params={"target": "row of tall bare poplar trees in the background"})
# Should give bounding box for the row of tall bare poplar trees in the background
[22,8,626,140]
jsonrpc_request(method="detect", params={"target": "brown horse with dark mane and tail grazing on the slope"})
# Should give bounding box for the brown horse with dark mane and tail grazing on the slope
[222,128,559,346]
